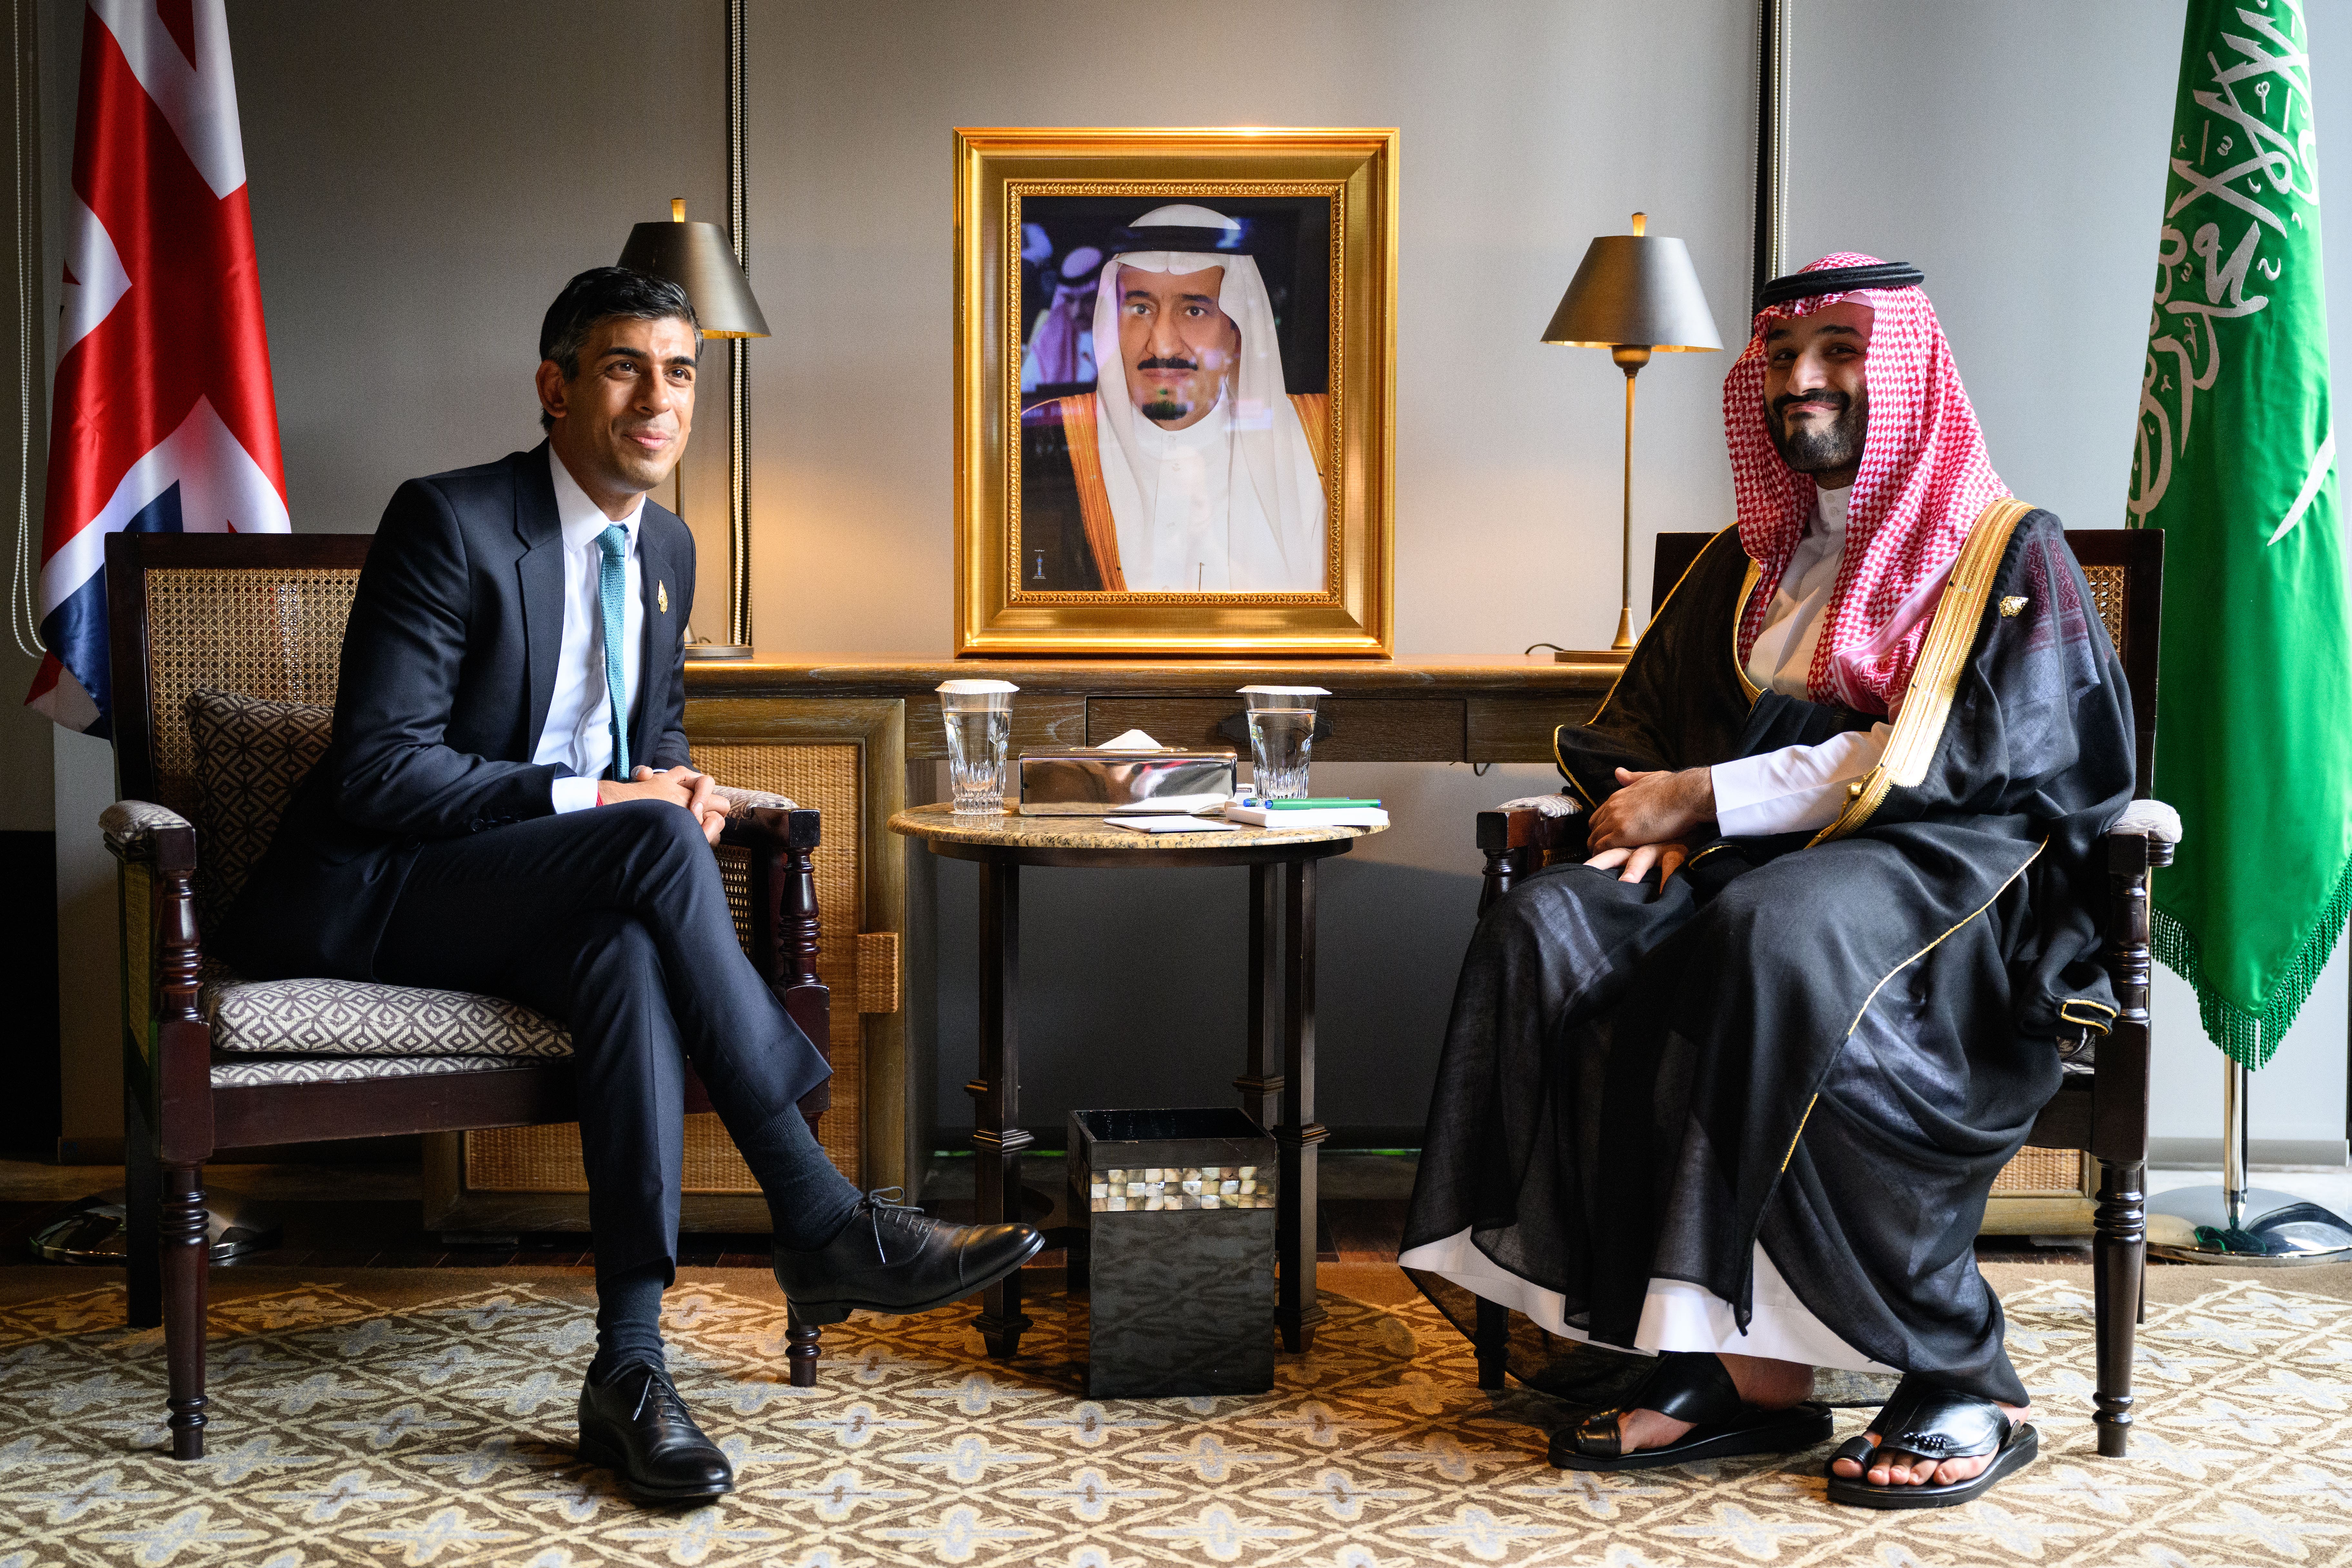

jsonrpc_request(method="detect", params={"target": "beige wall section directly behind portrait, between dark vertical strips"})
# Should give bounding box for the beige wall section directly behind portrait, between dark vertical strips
[748,0,1755,656]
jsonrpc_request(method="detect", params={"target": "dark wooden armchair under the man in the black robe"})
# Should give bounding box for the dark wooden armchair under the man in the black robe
[1475,529,2178,1457]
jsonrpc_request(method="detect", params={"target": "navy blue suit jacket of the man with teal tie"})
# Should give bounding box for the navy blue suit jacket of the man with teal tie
[216,442,694,980]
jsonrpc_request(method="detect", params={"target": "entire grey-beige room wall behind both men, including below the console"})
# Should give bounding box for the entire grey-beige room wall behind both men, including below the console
[32,0,2352,1152]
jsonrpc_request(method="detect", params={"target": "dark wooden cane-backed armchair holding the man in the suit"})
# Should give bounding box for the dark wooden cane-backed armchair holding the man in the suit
[101,534,830,1460]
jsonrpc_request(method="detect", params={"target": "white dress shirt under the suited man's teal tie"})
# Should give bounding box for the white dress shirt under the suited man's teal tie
[531,447,644,811]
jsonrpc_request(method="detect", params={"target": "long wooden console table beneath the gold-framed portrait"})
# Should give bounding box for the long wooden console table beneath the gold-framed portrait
[687,653,1623,1201]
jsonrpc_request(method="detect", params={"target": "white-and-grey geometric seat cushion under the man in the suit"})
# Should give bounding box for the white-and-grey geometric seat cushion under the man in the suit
[202,971,571,1062]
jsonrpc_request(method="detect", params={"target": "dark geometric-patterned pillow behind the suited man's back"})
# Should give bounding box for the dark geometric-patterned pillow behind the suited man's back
[188,689,334,921]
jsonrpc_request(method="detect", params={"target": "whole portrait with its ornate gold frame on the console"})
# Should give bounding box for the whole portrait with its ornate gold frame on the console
[955,129,1397,658]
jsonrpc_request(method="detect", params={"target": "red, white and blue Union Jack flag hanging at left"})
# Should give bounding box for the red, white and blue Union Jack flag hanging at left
[26,0,287,736]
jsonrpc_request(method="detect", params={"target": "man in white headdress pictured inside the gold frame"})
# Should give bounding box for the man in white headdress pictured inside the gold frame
[1018,202,1331,592]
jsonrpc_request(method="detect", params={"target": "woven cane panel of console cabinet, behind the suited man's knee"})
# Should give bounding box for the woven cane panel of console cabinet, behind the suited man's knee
[694,745,866,1180]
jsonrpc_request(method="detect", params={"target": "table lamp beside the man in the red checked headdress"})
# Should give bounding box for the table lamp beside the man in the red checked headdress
[1543,212,1724,658]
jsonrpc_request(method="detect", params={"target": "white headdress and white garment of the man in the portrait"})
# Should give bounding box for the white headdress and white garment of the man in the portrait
[1094,204,1329,592]
